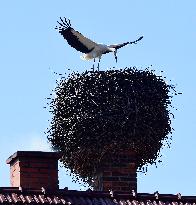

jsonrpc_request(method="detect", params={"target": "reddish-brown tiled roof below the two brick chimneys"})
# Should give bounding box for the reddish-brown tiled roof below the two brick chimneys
[0,187,196,205]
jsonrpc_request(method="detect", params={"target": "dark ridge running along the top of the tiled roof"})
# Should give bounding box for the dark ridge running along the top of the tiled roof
[0,187,196,203]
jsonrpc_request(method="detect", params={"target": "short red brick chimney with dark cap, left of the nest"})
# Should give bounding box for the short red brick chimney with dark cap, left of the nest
[6,151,60,189]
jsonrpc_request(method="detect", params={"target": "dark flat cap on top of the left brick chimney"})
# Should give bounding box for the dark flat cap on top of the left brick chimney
[6,151,62,164]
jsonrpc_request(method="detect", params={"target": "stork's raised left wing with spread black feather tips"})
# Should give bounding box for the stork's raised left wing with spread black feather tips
[55,17,97,53]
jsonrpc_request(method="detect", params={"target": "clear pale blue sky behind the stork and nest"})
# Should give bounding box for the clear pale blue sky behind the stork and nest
[0,0,196,195]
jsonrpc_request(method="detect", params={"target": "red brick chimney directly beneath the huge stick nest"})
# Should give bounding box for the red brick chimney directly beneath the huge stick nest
[94,151,137,192]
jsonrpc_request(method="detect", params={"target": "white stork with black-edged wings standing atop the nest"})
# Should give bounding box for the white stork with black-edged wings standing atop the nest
[55,17,143,71]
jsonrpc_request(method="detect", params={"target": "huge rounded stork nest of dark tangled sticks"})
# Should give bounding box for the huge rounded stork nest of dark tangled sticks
[47,68,176,182]
